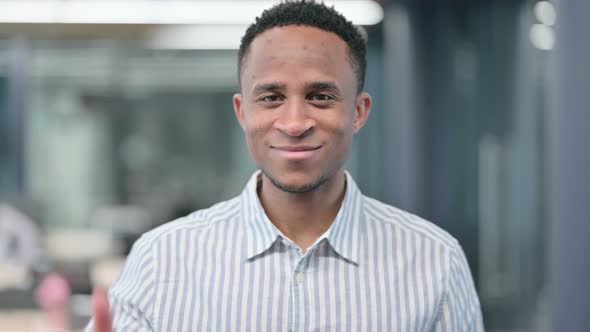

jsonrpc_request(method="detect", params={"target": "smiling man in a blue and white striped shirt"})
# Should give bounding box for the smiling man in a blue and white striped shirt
[89,1,483,331]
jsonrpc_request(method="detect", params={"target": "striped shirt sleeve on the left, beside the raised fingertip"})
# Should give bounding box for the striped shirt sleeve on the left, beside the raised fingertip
[86,237,155,332]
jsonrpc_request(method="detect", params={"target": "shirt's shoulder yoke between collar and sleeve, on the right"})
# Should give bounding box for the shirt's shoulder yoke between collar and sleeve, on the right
[363,196,460,253]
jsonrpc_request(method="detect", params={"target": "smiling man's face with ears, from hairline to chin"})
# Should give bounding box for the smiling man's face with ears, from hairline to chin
[234,26,371,192]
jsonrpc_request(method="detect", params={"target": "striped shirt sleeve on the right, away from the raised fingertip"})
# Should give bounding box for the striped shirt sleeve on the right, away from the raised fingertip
[432,244,484,332]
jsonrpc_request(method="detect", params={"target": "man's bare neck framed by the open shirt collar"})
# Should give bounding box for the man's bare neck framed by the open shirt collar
[259,170,346,252]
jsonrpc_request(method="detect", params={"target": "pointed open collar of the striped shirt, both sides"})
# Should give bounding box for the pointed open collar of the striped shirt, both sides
[241,171,364,264]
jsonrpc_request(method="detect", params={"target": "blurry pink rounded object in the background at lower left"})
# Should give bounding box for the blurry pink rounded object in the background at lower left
[35,273,72,331]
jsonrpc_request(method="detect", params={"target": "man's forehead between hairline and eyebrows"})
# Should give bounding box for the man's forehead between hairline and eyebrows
[241,26,354,89]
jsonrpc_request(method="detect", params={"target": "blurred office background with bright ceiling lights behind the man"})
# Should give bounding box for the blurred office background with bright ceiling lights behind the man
[0,0,590,331]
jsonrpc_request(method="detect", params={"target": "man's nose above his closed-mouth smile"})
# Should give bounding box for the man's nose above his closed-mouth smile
[274,101,316,137]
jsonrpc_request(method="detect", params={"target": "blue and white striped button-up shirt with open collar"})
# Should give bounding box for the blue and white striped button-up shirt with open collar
[89,172,483,332]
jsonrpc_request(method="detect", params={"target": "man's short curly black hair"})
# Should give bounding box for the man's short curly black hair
[238,0,367,92]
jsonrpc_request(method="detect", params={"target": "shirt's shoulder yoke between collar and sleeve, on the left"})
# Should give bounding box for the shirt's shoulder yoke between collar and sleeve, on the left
[136,196,241,246]
